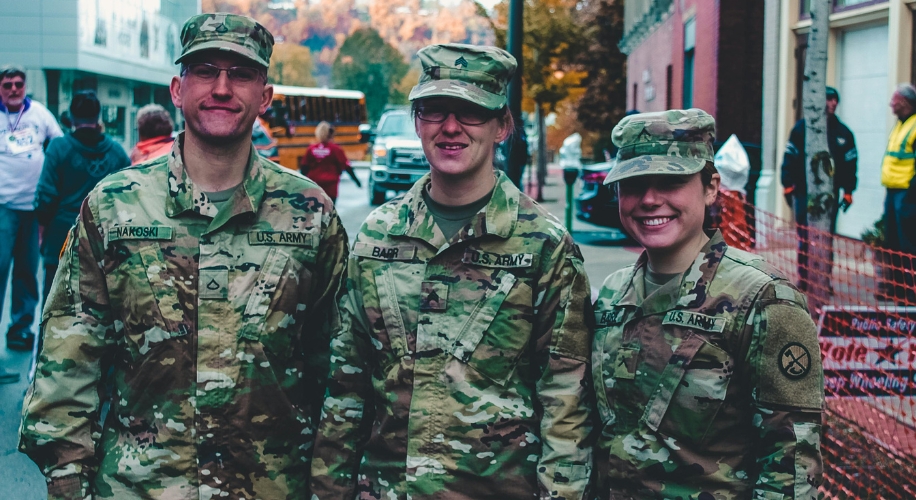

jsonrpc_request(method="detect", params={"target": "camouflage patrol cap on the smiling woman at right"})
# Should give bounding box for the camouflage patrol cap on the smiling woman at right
[604,109,716,184]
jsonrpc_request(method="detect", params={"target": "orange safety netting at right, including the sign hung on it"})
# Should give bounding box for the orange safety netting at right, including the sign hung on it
[714,191,916,499]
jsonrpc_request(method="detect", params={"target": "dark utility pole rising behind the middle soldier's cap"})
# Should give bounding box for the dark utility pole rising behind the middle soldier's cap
[506,0,528,187]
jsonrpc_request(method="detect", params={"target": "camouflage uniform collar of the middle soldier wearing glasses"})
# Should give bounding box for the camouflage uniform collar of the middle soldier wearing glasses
[388,171,520,251]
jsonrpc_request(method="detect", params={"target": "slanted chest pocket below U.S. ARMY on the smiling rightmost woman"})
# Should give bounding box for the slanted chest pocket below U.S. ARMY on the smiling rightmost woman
[646,334,735,443]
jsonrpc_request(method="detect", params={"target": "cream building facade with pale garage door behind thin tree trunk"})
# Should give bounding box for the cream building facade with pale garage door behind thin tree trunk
[758,0,916,238]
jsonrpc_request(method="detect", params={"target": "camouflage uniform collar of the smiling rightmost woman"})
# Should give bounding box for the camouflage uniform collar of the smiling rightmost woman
[616,230,728,316]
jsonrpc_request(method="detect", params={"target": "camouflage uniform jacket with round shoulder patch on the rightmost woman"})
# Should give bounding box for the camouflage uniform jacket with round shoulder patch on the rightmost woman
[592,233,824,500]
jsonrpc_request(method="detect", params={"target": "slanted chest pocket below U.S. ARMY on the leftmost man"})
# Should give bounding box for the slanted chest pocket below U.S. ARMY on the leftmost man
[239,247,317,358]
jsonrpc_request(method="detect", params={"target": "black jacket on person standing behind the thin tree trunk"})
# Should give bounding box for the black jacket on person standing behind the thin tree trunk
[781,115,859,223]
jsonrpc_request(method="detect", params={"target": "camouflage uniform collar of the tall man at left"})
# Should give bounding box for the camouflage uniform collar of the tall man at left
[166,132,266,231]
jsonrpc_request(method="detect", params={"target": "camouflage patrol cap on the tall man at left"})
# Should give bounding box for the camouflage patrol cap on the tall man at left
[175,12,274,68]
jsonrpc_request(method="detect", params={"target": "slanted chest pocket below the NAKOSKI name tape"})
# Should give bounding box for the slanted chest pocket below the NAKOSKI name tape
[108,242,188,359]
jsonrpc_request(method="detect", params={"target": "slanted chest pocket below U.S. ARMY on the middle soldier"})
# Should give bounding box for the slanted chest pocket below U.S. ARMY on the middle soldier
[451,271,532,386]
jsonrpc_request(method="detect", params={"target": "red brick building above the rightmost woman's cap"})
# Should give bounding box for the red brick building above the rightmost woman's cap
[620,0,764,145]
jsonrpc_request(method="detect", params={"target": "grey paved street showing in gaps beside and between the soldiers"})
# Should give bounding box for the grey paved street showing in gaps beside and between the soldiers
[0,165,638,500]
